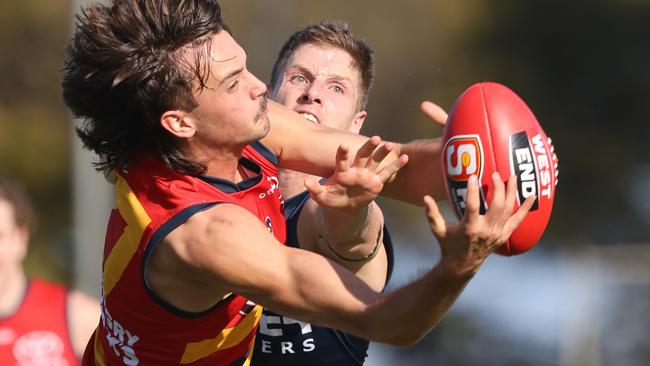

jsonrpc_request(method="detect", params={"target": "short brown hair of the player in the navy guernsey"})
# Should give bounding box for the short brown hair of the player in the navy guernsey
[271,21,375,110]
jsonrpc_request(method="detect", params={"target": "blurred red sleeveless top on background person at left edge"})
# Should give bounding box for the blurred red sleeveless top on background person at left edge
[0,279,79,366]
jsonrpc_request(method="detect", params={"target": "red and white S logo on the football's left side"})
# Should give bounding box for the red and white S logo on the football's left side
[443,135,487,217]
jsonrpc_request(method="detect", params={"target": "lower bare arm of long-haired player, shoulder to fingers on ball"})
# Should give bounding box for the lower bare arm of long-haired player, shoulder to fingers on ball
[147,172,533,345]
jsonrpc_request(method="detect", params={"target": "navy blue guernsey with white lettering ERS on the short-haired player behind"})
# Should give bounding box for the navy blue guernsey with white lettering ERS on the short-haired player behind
[251,191,393,366]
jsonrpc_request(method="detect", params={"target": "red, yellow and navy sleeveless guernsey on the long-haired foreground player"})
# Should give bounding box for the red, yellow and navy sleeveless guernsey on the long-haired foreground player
[83,143,285,366]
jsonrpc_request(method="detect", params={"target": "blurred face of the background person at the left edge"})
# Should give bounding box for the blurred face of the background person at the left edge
[0,199,27,278]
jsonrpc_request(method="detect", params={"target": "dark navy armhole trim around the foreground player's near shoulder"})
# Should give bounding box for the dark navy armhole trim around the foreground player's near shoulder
[141,202,235,319]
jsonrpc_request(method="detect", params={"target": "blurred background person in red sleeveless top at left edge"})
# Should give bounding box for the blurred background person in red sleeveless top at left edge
[0,176,99,366]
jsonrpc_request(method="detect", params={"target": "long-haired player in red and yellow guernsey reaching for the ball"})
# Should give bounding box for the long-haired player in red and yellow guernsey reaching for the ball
[63,0,530,366]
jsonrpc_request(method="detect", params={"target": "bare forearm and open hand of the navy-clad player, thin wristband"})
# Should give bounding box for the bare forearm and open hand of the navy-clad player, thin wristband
[298,136,406,291]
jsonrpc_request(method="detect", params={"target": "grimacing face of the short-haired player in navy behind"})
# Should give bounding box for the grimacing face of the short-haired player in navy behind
[273,44,366,133]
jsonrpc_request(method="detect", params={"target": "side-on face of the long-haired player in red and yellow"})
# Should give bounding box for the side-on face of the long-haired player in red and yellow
[190,31,269,147]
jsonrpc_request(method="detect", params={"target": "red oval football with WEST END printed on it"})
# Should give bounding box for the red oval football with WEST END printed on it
[442,82,558,255]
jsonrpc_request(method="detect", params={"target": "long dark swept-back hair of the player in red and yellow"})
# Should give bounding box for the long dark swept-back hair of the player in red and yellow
[62,0,228,174]
